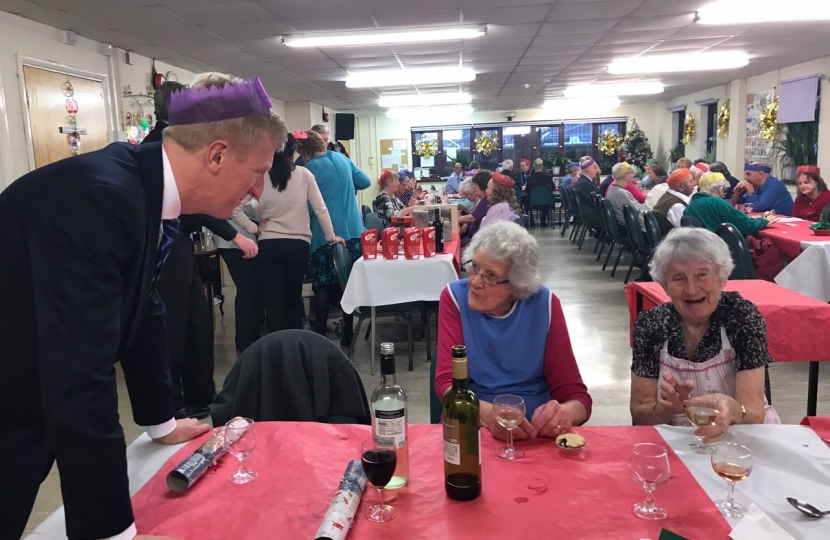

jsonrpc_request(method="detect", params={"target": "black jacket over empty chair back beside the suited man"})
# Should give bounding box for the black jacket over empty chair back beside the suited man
[210,330,371,426]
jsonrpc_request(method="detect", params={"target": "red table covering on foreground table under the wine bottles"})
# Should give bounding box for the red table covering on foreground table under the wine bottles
[133,422,730,540]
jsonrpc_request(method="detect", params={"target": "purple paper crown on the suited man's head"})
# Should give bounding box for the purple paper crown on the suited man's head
[168,77,271,126]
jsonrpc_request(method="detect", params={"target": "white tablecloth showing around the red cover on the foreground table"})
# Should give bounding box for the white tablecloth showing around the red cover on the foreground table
[26,425,830,540]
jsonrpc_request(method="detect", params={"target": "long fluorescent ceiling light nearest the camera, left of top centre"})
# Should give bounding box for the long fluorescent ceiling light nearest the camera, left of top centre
[282,24,487,47]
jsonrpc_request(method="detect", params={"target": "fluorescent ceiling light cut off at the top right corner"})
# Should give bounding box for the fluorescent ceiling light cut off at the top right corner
[695,0,830,24]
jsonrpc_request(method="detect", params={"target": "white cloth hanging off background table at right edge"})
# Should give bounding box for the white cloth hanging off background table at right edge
[775,242,830,304]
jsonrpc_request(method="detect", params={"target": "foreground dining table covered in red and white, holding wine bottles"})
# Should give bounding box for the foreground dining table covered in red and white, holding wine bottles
[27,422,830,540]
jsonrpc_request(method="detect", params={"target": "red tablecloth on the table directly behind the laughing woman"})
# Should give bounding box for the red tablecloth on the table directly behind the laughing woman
[625,279,830,362]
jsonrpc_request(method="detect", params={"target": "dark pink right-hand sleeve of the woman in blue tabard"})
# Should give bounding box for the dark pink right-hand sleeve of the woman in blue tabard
[544,293,593,422]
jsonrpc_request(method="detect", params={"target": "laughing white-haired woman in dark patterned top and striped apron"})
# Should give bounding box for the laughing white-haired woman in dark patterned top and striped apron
[630,227,781,442]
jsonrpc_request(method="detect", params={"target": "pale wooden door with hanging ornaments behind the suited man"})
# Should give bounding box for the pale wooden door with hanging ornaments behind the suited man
[23,66,107,168]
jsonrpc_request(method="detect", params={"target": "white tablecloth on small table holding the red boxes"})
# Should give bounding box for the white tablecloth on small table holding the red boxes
[340,253,458,313]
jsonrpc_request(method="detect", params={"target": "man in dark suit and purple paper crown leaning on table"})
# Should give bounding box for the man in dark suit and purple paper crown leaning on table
[0,74,286,540]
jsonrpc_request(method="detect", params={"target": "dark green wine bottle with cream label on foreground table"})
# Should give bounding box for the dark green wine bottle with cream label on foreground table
[443,345,481,501]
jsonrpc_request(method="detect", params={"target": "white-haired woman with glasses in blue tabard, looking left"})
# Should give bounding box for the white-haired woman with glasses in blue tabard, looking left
[434,221,592,439]
